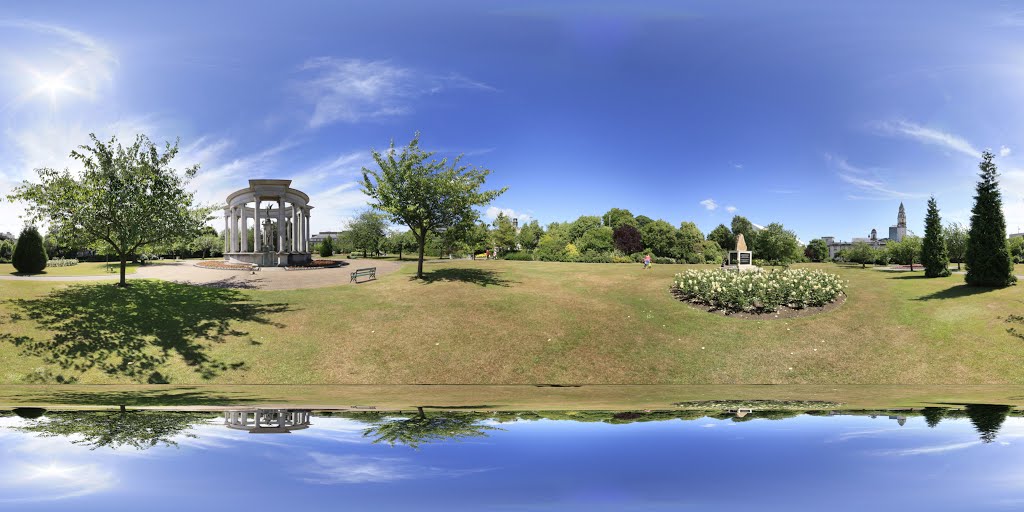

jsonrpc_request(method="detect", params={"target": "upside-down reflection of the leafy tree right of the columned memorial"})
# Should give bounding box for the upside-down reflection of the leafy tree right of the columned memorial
[362,408,502,449]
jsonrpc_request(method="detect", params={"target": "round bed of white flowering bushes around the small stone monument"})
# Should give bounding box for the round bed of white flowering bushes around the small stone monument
[673,268,844,311]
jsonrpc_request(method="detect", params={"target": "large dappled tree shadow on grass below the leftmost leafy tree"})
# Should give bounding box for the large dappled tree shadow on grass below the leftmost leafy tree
[0,280,289,384]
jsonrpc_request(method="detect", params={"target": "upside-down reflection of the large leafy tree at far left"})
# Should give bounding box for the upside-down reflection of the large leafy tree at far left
[15,407,210,450]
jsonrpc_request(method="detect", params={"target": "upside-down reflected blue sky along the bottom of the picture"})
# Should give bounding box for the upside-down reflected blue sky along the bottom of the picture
[0,416,1024,511]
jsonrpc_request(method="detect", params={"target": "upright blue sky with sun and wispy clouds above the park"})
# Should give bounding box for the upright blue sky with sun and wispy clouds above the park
[0,1,1024,241]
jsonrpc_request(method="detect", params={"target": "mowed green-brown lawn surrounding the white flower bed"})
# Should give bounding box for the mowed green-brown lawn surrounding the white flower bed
[0,261,1024,384]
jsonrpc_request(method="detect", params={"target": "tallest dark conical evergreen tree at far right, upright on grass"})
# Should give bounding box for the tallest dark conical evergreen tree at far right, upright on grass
[966,151,1017,287]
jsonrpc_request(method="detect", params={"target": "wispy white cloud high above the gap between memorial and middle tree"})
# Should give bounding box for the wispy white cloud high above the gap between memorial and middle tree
[299,57,495,128]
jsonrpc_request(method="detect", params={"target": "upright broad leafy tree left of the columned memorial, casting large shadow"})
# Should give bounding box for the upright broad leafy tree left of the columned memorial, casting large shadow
[9,134,210,287]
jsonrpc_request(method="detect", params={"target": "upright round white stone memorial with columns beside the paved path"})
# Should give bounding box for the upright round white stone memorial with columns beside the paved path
[224,179,313,266]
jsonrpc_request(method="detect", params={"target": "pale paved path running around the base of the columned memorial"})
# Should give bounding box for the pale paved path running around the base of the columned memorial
[0,259,400,290]
